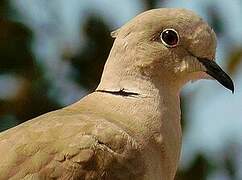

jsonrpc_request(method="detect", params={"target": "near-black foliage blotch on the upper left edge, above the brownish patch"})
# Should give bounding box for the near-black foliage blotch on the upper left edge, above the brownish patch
[0,19,35,77]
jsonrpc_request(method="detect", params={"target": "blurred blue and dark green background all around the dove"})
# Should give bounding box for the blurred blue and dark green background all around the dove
[0,0,242,180]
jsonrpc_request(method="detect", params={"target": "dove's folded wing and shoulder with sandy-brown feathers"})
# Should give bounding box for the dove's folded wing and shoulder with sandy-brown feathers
[0,109,143,179]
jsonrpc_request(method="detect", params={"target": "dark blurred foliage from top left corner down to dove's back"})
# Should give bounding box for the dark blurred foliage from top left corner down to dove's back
[0,1,60,127]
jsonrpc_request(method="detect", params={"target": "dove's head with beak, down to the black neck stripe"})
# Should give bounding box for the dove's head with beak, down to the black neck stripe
[98,8,234,95]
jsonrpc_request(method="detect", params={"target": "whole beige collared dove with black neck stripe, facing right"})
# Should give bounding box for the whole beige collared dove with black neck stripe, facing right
[0,9,234,180]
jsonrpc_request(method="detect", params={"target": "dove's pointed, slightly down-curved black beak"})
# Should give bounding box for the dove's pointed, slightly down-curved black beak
[198,58,234,93]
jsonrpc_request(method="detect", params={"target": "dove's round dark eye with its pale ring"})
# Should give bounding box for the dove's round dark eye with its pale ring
[160,29,179,48]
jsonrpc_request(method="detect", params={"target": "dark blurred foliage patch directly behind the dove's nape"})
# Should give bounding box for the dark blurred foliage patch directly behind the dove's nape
[70,14,113,91]
